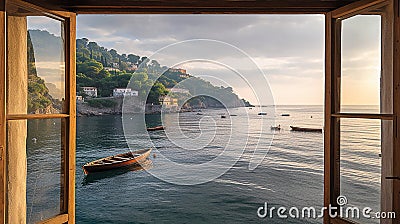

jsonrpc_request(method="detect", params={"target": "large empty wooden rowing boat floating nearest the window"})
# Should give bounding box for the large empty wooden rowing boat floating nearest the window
[82,149,151,174]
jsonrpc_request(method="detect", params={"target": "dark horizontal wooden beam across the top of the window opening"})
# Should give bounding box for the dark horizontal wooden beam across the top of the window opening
[22,0,356,14]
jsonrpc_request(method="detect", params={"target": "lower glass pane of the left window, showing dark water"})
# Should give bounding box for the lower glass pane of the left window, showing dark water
[26,119,62,223]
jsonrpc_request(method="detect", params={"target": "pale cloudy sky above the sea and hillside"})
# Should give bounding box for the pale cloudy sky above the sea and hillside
[32,15,380,105]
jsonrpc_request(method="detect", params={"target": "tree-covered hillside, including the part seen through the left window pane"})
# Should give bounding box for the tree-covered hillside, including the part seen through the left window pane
[28,30,248,113]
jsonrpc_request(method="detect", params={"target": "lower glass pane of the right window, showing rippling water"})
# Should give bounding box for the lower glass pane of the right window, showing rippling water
[340,119,382,223]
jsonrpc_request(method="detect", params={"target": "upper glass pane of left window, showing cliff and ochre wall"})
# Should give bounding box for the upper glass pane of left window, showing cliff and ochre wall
[7,5,65,114]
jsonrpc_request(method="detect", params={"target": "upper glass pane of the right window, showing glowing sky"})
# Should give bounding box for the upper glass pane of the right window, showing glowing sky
[340,15,382,113]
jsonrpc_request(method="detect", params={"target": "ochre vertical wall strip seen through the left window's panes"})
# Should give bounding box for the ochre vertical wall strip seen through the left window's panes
[6,15,28,223]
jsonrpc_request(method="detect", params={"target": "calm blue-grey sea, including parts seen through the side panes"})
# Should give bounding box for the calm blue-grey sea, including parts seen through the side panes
[27,106,381,224]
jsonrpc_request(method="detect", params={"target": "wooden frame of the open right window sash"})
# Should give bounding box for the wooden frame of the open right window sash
[324,0,400,224]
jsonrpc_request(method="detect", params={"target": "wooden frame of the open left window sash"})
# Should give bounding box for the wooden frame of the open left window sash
[0,0,76,224]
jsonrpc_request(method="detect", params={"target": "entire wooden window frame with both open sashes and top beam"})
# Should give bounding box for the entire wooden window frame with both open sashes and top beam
[0,0,400,224]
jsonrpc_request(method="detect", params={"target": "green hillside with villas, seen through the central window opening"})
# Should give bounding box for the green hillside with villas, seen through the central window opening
[76,38,250,107]
